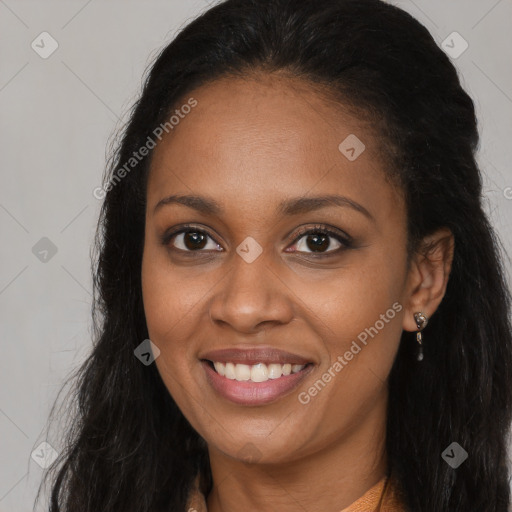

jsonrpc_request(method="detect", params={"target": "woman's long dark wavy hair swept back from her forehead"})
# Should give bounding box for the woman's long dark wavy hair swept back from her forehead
[41,0,512,512]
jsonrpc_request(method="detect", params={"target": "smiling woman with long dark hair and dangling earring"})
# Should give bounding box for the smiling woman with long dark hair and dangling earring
[42,0,512,512]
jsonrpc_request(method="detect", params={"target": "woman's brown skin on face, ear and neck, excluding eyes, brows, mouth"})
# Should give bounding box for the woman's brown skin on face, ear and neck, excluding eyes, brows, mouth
[142,75,453,512]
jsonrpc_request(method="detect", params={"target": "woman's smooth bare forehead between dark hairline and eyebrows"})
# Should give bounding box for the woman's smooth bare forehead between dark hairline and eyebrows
[144,76,400,220]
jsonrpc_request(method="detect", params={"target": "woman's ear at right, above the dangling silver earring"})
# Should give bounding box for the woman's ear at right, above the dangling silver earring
[403,228,455,332]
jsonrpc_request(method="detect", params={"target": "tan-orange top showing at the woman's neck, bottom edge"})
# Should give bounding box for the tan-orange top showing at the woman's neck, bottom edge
[186,477,406,512]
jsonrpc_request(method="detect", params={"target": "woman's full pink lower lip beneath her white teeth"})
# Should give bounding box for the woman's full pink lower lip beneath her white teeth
[201,361,313,405]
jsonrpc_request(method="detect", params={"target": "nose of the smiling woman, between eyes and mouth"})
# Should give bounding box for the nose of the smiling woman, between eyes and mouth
[210,253,294,333]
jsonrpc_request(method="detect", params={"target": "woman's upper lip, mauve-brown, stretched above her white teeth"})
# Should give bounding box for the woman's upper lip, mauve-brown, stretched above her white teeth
[200,347,312,365]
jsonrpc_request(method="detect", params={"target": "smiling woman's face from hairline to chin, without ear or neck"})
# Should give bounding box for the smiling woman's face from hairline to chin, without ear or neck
[142,76,407,463]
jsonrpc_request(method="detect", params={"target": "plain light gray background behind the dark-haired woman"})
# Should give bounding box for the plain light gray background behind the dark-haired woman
[0,0,512,512]
